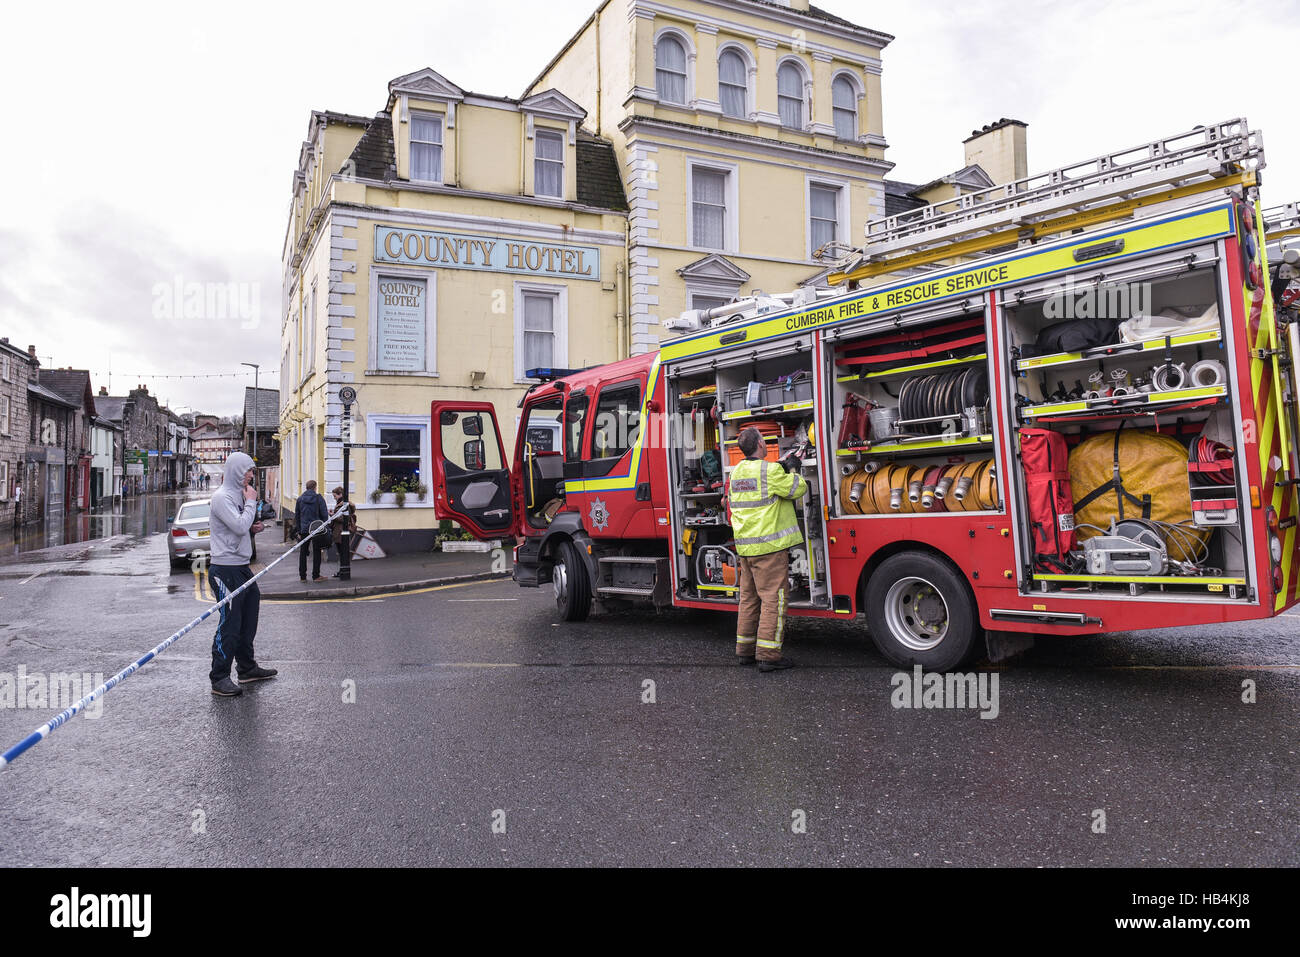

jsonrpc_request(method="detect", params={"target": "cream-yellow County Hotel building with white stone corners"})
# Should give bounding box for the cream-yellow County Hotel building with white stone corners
[280,0,892,550]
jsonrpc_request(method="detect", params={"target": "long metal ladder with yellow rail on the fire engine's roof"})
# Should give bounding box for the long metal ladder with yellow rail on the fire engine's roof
[828,118,1264,285]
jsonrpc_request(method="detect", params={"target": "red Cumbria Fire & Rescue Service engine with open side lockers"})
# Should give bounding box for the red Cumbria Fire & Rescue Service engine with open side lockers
[432,120,1300,670]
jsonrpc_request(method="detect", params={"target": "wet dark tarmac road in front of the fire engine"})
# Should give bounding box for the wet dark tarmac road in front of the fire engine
[0,536,1300,866]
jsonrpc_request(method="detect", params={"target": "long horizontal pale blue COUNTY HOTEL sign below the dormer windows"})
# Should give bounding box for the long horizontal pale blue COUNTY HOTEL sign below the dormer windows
[374,226,601,281]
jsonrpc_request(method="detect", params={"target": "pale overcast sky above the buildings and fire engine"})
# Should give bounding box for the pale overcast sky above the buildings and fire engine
[0,0,1300,413]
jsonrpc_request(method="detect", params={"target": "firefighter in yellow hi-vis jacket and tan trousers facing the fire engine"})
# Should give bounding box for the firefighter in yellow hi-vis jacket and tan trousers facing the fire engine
[727,428,809,672]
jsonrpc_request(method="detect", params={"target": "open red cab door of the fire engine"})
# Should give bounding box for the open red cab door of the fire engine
[430,402,515,540]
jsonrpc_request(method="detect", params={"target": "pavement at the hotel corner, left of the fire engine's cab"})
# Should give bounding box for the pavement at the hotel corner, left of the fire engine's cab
[252,528,510,599]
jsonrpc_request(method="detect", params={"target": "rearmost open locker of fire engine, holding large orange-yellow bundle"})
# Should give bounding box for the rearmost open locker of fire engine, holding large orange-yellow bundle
[1004,256,1249,599]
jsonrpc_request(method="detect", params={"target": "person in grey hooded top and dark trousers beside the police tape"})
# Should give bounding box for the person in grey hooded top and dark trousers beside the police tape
[208,452,278,697]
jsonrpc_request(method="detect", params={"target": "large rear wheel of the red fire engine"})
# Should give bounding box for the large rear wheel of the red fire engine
[863,551,980,671]
